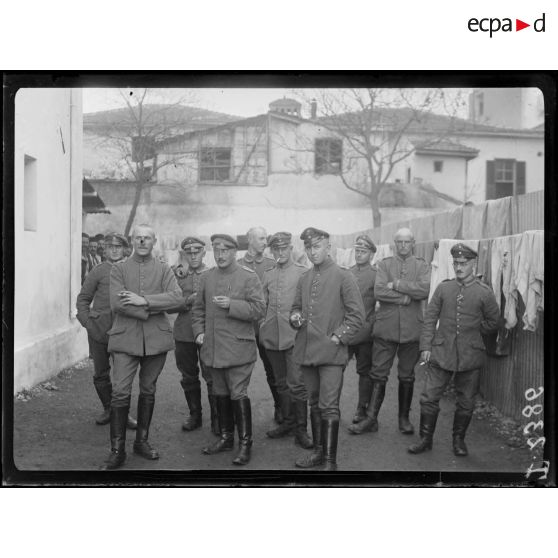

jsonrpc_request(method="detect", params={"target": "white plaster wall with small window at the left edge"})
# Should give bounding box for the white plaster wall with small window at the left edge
[14,89,87,391]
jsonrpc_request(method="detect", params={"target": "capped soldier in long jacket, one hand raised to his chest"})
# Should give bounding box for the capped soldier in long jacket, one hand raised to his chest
[192,234,265,465]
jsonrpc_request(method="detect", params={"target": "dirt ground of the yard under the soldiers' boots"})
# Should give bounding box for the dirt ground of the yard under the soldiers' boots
[13,353,532,480]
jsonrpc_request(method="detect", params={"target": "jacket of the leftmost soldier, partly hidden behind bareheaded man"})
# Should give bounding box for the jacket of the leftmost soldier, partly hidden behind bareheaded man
[76,262,113,344]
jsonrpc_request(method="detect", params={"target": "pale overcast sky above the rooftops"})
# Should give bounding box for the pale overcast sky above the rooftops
[83,88,469,118]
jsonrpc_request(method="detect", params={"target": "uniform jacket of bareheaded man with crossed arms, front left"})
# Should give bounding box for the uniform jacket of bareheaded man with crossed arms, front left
[108,254,183,356]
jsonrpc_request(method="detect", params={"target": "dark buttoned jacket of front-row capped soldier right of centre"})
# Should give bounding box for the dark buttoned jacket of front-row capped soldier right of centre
[291,258,364,372]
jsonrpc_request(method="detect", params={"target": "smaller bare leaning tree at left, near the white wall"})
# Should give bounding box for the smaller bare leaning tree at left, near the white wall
[86,88,200,235]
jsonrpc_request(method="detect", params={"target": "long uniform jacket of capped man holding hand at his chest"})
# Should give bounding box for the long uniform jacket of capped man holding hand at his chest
[192,262,265,368]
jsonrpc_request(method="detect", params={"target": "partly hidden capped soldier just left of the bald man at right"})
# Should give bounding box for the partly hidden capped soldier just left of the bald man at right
[349,234,376,424]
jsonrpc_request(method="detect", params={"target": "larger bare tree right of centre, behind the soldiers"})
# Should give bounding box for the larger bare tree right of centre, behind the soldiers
[298,88,470,227]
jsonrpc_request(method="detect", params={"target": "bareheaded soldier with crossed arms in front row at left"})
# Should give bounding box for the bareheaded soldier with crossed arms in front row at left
[106,225,183,469]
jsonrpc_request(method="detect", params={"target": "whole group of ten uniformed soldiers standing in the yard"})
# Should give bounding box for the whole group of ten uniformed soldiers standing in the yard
[77,225,499,471]
